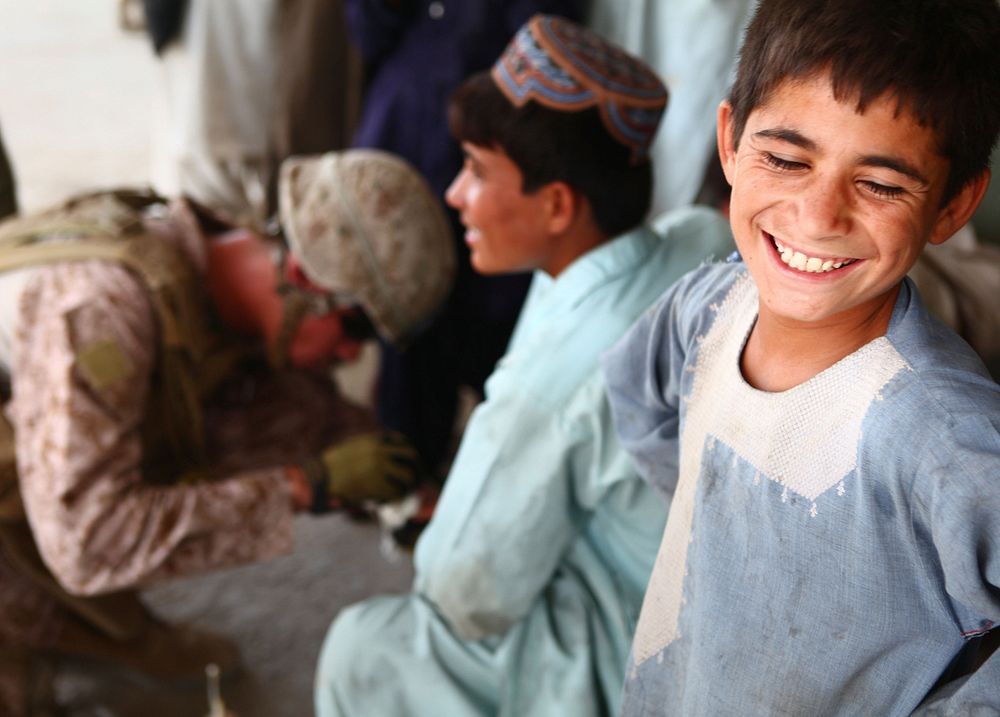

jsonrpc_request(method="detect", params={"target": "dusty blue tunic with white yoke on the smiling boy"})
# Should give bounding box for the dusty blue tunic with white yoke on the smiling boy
[605,264,1000,717]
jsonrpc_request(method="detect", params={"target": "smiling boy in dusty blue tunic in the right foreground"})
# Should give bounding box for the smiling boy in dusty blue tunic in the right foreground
[605,0,1000,717]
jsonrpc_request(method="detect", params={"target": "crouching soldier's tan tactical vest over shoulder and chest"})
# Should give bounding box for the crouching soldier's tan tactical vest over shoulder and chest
[0,190,228,517]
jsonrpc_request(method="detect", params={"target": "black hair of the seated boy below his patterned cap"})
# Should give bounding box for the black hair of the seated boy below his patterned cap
[448,72,653,237]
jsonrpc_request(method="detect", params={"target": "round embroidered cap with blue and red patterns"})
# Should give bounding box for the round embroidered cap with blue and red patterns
[492,15,667,163]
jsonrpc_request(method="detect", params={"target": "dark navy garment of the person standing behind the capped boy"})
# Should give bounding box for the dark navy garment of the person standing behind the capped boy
[344,0,582,468]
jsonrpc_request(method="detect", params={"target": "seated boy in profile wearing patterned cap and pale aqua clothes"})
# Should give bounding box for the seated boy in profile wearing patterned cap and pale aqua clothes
[316,16,731,717]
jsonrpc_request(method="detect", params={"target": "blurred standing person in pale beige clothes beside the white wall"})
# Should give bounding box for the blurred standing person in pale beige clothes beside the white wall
[143,0,361,226]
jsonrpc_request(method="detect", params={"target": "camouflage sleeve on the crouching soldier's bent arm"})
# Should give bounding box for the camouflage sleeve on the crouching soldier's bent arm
[9,262,292,594]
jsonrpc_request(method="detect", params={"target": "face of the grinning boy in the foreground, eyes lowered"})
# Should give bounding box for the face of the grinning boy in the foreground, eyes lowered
[719,74,987,333]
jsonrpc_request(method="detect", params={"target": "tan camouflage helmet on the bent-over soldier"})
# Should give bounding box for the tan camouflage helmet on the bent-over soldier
[278,149,456,342]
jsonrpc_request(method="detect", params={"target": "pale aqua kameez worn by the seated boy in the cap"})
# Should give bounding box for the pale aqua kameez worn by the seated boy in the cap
[316,208,731,717]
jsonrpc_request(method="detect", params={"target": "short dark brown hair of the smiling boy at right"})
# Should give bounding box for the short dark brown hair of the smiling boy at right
[730,0,1000,203]
